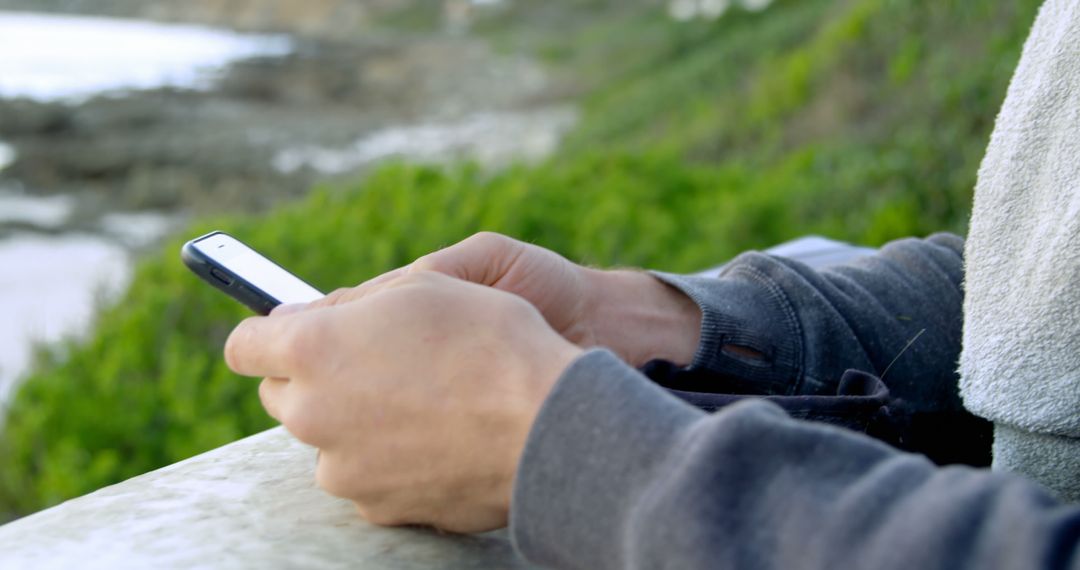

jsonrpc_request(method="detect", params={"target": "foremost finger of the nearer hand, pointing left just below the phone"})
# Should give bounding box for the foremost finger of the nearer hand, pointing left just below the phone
[225,312,307,378]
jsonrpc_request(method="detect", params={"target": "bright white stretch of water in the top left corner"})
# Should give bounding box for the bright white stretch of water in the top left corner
[0,12,292,103]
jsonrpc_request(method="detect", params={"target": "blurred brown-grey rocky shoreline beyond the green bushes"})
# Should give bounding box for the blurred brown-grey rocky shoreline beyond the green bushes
[0,27,566,222]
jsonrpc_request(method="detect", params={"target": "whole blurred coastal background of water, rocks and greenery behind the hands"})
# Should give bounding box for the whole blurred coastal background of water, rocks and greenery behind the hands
[0,0,1040,523]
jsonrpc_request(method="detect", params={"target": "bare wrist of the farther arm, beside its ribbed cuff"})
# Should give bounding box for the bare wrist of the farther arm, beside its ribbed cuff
[585,269,702,366]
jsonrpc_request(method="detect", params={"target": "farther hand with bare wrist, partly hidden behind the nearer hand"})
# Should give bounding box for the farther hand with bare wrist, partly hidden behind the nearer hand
[315,232,701,366]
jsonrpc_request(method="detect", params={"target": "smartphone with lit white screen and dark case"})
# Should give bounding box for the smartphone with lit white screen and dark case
[180,231,323,315]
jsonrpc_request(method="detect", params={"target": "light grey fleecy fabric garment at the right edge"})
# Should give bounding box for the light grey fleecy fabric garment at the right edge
[960,0,1080,501]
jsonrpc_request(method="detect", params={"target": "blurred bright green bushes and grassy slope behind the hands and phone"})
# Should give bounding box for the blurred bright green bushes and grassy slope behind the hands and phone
[0,0,1040,517]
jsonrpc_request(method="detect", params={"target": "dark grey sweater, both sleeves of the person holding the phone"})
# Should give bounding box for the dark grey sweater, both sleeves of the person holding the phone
[511,235,1080,569]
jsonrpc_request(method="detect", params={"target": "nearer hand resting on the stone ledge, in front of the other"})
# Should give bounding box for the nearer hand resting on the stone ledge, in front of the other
[226,271,581,532]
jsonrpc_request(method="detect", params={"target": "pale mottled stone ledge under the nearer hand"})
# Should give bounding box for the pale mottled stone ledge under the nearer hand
[0,428,530,569]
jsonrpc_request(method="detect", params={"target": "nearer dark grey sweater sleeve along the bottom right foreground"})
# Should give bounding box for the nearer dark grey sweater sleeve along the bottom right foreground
[511,350,1080,569]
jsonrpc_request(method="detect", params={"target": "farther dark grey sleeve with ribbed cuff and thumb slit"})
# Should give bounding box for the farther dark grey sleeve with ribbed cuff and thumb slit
[656,234,963,410]
